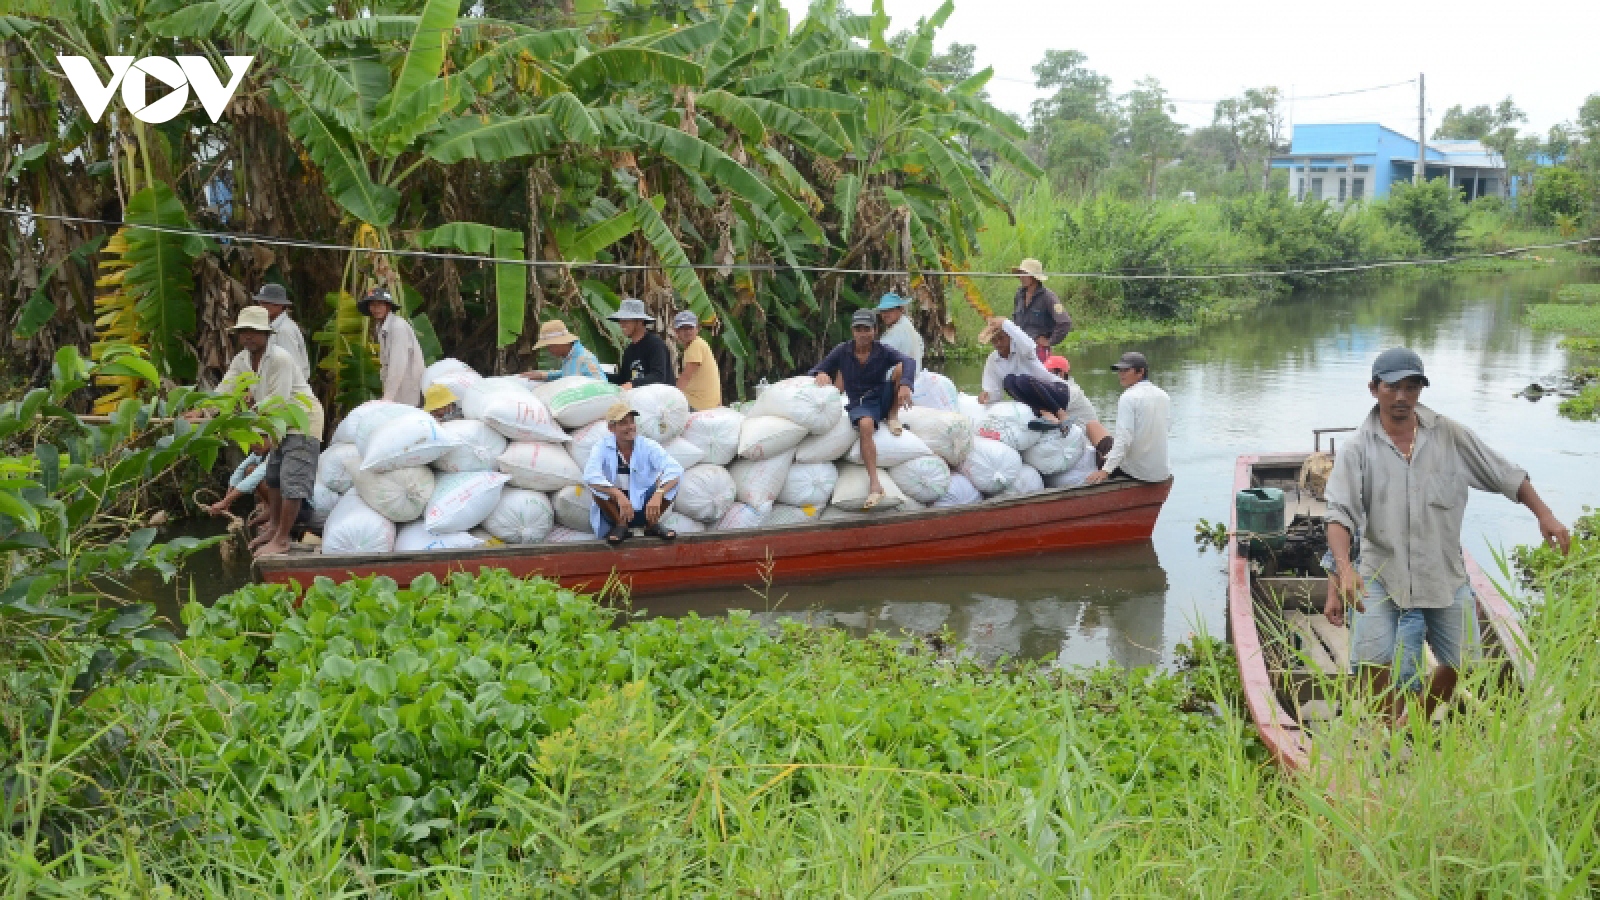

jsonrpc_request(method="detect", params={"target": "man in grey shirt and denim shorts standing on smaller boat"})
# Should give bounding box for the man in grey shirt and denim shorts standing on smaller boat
[1325,348,1571,717]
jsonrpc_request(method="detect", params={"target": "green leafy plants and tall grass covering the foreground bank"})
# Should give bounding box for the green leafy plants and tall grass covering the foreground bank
[0,519,1600,898]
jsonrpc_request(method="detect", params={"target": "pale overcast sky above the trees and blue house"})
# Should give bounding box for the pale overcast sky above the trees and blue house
[784,0,1600,136]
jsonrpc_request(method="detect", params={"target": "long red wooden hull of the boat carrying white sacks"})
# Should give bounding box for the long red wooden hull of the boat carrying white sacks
[256,479,1173,594]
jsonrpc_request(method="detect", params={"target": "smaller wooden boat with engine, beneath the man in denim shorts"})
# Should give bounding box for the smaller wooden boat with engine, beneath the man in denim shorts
[1227,453,1533,772]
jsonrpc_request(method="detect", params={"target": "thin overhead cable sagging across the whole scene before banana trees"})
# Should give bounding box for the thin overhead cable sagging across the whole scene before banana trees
[0,207,1600,282]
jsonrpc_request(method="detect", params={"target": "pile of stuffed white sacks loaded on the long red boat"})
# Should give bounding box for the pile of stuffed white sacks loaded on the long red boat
[317,359,1094,554]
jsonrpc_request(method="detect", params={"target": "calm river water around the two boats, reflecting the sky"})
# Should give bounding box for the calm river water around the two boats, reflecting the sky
[152,266,1600,666]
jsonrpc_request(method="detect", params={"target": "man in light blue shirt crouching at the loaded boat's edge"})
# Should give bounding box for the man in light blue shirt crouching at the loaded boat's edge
[584,400,683,546]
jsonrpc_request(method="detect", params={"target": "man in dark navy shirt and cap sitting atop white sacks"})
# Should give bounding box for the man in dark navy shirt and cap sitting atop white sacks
[810,309,917,509]
